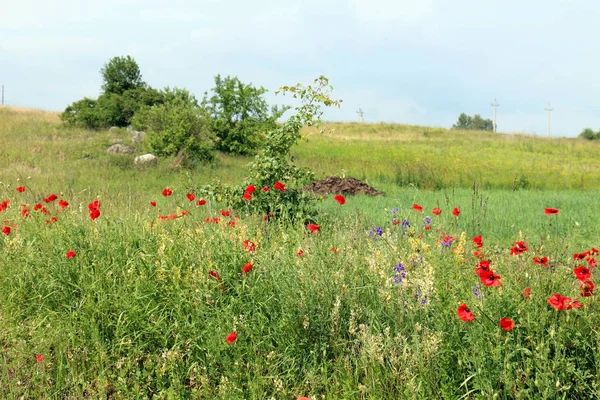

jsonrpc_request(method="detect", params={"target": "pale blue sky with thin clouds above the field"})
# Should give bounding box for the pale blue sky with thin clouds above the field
[0,0,600,137]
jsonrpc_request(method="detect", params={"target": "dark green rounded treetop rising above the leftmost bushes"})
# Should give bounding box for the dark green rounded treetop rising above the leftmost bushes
[100,56,146,95]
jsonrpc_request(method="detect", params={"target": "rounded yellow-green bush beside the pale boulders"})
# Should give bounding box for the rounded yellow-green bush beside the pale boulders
[132,88,214,161]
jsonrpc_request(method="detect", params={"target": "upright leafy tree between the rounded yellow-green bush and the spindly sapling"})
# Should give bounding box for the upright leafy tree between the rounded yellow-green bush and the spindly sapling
[202,75,288,154]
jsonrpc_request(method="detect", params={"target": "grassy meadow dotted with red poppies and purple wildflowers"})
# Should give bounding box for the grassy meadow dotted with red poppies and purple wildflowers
[0,104,600,399]
